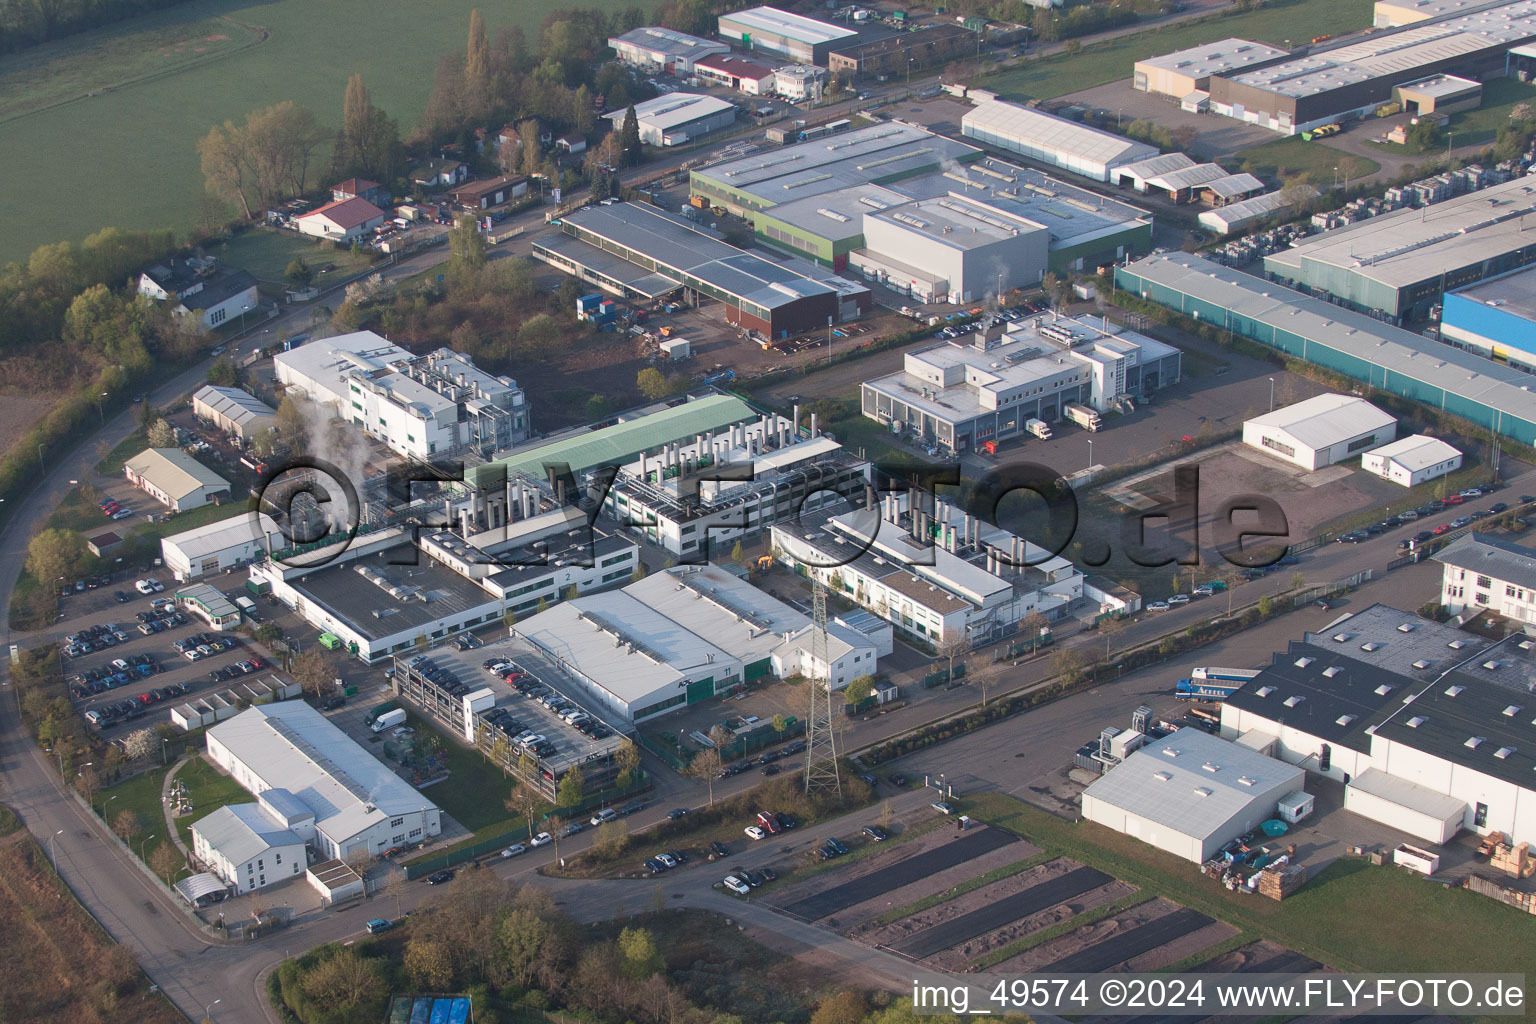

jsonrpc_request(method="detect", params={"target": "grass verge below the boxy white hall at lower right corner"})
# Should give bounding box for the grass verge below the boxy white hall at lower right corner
[958,794,1536,973]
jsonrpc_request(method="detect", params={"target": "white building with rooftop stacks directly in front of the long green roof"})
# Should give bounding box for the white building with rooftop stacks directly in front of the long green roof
[604,408,871,562]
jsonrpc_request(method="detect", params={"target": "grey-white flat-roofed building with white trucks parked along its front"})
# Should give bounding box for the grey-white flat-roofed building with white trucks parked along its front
[860,316,1183,453]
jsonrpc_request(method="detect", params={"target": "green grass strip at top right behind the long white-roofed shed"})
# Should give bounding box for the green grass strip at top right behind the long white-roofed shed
[978,0,1372,100]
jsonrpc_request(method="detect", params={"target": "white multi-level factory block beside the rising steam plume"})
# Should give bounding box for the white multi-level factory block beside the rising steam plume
[273,330,531,459]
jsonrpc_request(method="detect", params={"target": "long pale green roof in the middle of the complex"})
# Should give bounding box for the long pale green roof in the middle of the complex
[468,395,757,488]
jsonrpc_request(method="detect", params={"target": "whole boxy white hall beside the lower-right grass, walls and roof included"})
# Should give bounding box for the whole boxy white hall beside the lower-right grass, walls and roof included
[1083,729,1307,864]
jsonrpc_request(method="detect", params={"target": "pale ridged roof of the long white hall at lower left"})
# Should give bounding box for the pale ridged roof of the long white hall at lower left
[209,700,436,846]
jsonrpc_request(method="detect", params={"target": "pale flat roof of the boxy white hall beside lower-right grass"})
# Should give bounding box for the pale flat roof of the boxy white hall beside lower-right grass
[1083,729,1306,840]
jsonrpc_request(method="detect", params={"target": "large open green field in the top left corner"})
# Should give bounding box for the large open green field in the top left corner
[0,0,648,261]
